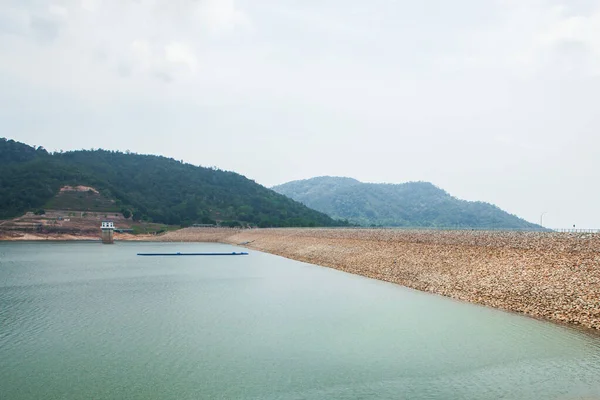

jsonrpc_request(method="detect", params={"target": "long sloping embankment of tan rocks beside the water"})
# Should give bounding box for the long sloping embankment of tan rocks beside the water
[152,228,600,329]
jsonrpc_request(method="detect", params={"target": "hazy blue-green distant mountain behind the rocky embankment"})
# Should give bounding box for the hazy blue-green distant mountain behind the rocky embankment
[272,176,542,229]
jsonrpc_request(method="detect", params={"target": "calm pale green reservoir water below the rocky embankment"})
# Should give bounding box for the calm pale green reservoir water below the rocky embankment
[0,242,600,400]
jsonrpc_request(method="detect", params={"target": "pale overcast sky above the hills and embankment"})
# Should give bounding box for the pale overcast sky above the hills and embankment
[0,0,600,228]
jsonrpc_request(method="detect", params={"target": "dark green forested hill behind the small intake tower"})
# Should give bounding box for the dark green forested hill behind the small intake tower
[0,138,342,227]
